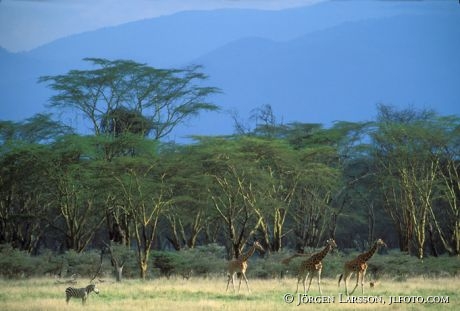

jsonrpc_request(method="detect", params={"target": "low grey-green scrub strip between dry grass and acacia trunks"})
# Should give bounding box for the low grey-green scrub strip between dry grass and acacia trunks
[0,244,460,281]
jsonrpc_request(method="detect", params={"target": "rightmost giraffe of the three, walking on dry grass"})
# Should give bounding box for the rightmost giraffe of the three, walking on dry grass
[339,239,387,295]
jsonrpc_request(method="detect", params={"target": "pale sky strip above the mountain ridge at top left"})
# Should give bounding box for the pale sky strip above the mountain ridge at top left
[0,0,326,52]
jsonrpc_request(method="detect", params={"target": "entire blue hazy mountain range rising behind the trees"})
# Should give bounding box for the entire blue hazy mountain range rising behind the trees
[0,1,460,138]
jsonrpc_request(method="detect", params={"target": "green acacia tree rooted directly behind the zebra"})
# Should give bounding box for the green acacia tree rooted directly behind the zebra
[47,136,105,252]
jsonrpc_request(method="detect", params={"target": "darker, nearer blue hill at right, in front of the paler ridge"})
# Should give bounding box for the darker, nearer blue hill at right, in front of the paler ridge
[192,15,460,135]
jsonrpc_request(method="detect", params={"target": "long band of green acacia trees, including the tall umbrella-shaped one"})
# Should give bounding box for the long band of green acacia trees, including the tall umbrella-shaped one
[0,58,460,277]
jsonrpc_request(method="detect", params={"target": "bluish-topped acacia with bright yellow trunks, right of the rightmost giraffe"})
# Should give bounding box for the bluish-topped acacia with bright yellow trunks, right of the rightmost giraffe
[372,106,456,259]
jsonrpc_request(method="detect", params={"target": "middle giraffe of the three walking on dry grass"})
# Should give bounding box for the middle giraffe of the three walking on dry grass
[296,239,337,295]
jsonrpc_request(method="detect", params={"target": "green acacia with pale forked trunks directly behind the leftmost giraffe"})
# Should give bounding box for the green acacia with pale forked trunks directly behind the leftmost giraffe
[203,138,263,258]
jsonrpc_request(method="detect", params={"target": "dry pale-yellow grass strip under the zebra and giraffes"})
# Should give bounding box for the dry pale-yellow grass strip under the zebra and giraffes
[0,278,460,311]
